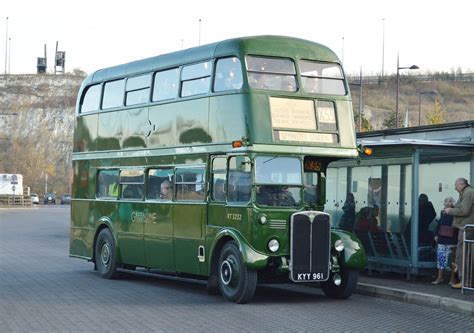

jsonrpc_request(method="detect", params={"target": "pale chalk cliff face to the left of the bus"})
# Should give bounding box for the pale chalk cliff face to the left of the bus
[0,75,84,191]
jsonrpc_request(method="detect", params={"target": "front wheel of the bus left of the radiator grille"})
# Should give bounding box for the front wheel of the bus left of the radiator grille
[217,241,257,304]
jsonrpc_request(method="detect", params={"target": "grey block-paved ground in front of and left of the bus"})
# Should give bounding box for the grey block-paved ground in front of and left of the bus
[0,207,474,332]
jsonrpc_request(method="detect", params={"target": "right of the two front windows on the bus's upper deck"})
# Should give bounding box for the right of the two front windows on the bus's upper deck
[299,60,346,95]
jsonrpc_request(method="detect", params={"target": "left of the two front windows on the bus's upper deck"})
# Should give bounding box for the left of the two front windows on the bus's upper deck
[246,56,298,91]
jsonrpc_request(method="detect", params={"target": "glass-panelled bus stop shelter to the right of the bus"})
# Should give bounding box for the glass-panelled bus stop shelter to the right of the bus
[326,122,474,276]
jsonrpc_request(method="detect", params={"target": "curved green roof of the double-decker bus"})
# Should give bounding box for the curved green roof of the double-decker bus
[83,36,340,86]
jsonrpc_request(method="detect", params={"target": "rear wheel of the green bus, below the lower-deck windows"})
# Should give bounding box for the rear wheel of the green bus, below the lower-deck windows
[95,228,118,279]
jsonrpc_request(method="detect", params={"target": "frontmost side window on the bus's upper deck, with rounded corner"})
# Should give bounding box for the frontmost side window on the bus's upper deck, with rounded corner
[214,57,243,92]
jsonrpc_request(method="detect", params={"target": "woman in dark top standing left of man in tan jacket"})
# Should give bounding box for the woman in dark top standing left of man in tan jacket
[431,197,458,285]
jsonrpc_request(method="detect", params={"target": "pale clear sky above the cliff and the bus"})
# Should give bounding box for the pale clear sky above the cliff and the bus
[0,0,474,75]
